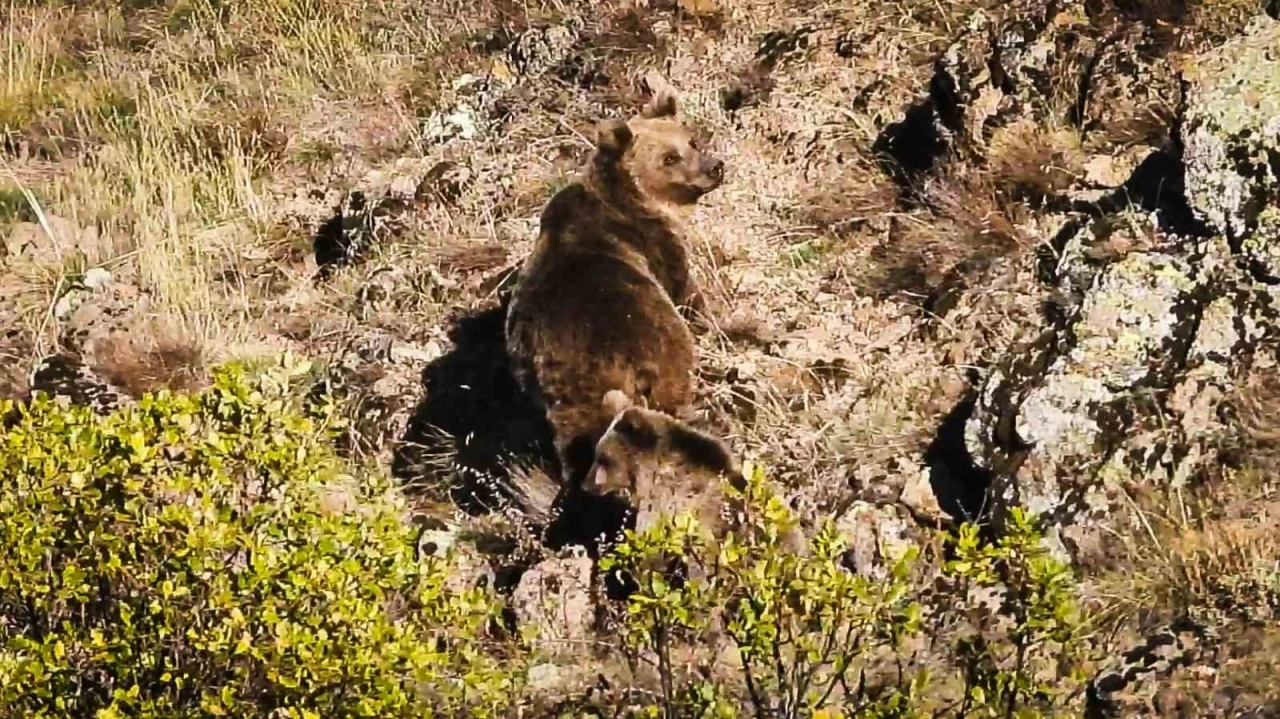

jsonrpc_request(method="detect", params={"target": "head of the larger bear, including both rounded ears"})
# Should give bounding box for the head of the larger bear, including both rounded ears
[595,88,724,206]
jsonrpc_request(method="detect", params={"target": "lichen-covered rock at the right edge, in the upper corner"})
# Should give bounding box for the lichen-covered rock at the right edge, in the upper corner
[1183,17,1280,281]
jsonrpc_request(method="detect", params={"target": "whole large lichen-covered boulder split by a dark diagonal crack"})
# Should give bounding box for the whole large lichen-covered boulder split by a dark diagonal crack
[965,223,1277,560]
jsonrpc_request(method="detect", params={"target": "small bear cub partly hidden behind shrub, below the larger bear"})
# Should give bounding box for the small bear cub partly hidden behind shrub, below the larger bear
[582,390,741,501]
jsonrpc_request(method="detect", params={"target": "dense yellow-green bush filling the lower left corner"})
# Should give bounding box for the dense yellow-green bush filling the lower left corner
[0,353,522,719]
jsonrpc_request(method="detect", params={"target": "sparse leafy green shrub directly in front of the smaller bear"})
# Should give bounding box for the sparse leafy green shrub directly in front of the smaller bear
[602,460,922,719]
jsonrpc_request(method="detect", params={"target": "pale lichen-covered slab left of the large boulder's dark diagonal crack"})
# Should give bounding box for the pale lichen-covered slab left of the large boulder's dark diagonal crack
[966,232,1225,522]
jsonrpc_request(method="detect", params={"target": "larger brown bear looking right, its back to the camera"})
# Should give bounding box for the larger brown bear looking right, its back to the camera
[506,85,723,485]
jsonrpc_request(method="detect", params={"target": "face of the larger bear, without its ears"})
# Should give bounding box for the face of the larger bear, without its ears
[625,116,724,205]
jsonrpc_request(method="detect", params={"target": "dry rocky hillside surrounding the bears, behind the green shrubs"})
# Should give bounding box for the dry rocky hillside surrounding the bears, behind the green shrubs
[0,0,1280,716]
